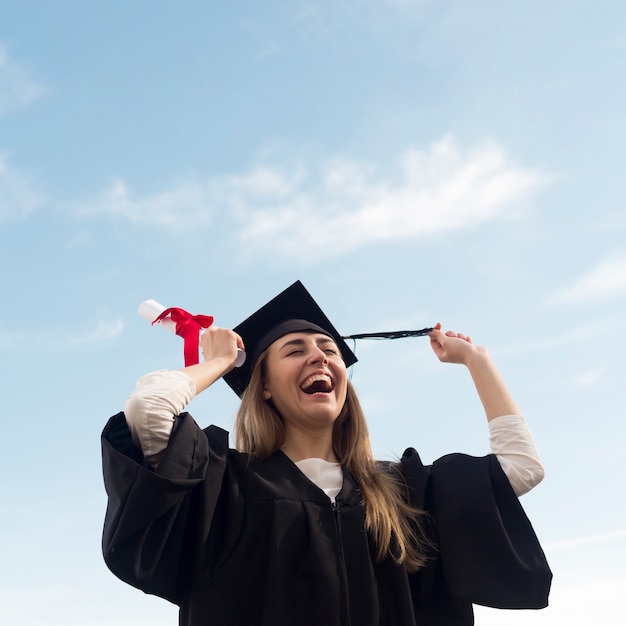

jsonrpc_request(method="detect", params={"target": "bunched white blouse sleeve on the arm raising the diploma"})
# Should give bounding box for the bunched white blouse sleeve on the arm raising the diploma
[124,370,196,465]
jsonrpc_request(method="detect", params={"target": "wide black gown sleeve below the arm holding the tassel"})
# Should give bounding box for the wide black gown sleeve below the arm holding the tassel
[402,449,552,626]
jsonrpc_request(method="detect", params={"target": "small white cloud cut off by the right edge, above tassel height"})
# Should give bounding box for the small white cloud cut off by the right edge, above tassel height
[550,251,626,304]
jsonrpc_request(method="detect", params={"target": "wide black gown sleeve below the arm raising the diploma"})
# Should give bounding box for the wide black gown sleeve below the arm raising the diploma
[102,413,228,604]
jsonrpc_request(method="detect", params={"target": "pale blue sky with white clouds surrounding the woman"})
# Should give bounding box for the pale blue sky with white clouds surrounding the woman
[0,0,626,626]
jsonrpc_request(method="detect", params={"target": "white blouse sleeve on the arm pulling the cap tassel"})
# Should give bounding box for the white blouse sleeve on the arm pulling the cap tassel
[489,415,544,496]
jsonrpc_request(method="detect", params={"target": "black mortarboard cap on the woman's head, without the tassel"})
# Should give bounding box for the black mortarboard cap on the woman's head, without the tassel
[224,281,357,396]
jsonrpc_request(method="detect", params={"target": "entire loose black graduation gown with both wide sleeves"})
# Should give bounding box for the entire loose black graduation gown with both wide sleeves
[102,413,551,626]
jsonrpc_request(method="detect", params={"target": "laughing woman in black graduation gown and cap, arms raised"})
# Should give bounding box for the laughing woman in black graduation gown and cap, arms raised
[102,282,551,626]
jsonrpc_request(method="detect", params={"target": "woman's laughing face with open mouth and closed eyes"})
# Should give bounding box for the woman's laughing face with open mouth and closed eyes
[263,332,348,430]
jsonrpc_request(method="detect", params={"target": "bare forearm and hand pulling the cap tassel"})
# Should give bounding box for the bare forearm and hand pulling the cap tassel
[430,324,520,421]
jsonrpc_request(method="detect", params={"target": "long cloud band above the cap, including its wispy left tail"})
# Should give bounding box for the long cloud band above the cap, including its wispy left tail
[80,136,549,261]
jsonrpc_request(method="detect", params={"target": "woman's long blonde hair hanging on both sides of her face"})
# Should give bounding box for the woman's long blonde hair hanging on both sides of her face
[235,353,433,571]
